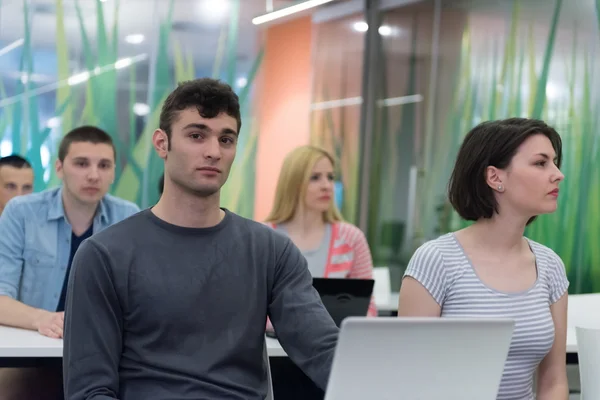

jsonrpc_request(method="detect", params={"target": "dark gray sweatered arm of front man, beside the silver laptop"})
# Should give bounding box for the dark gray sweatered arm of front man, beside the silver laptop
[269,240,338,390]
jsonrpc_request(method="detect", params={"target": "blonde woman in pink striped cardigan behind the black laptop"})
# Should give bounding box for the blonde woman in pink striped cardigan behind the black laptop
[266,146,377,316]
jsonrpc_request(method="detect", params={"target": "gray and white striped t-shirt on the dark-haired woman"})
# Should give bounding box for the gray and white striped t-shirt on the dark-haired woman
[405,233,569,400]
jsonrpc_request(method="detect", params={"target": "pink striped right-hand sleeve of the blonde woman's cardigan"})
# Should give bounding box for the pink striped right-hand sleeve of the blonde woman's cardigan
[340,223,377,317]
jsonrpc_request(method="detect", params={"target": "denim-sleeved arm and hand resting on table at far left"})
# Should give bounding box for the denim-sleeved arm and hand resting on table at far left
[0,201,62,338]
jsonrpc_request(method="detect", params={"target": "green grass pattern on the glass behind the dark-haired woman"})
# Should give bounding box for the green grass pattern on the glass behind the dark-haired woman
[421,0,600,293]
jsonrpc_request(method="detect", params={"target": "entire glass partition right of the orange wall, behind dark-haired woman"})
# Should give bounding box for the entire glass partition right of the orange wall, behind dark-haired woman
[332,0,600,293]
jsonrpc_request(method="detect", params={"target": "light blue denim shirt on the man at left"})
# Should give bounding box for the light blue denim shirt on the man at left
[0,187,140,311]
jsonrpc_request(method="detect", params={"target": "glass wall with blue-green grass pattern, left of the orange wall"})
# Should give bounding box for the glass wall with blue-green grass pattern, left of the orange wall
[0,0,262,217]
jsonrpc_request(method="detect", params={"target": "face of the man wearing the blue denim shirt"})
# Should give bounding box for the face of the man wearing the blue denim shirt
[56,142,115,205]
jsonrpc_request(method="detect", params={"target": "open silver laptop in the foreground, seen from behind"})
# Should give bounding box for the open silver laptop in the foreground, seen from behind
[325,317,514,400]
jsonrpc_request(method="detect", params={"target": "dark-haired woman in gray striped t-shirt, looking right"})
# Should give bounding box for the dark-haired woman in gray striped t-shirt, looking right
[398,118,569,400]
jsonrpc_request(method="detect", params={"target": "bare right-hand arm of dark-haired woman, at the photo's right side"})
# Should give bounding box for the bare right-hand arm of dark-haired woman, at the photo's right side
[537,293,569,400]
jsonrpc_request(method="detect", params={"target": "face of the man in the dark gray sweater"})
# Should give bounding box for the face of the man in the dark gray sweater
[153,107,238,197]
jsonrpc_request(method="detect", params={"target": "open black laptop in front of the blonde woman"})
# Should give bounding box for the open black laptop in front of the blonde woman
[313,278,375,327]
